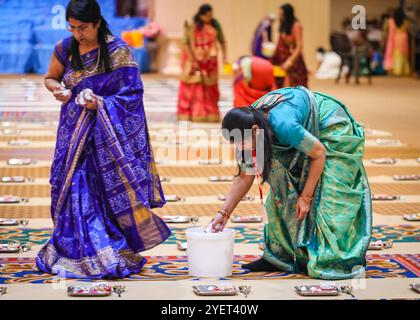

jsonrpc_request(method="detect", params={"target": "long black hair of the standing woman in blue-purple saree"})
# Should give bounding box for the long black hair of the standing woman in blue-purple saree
[66,0,112,72]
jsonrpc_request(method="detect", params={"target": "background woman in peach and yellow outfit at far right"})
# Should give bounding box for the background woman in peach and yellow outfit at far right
[385,7,410,76]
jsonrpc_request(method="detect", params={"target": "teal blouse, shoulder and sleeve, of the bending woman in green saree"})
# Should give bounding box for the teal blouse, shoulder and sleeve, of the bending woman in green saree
[268,87,318,154]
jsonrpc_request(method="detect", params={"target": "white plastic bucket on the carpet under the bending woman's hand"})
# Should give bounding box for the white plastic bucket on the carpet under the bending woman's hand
[186,227,235,278]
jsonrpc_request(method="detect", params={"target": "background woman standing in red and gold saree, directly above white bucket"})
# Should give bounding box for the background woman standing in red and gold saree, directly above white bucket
[177,4,227,122]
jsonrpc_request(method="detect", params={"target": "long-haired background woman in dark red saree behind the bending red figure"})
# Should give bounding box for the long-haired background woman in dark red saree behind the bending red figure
[272,3,308,88]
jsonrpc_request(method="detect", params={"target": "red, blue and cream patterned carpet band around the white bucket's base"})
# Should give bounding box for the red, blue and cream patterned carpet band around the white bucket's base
[0,254,420,284]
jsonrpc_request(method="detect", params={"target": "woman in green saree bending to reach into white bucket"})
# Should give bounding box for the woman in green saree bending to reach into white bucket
[212,86,372,279]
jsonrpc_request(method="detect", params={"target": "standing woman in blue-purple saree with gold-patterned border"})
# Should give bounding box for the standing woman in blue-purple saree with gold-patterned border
[36,0,170,279]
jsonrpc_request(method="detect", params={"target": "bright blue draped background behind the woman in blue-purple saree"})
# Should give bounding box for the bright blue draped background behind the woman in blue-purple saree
[0,0,149,74]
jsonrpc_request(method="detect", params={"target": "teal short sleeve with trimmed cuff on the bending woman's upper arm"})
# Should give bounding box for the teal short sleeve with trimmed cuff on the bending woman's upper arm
[268,96,317,154]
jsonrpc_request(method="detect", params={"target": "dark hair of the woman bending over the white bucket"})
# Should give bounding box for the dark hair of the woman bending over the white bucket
[222,107,273,183]
